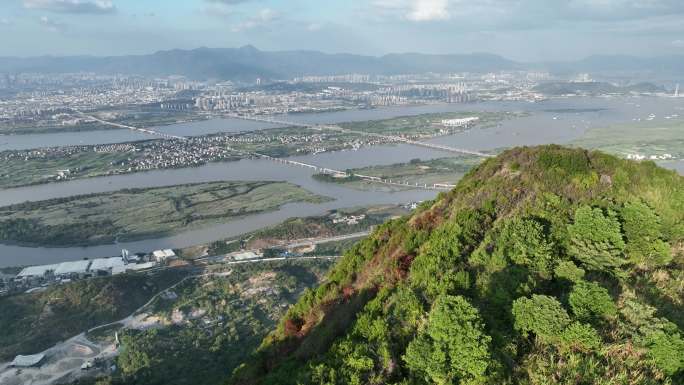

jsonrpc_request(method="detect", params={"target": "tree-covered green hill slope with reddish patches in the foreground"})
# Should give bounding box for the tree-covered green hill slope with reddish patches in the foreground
[231,146,684,385]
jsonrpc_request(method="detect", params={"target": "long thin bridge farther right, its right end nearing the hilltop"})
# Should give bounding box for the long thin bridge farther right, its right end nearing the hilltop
[229,114,494,158]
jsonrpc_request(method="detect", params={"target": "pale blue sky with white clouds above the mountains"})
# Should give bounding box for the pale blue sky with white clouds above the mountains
[0,0,684,61]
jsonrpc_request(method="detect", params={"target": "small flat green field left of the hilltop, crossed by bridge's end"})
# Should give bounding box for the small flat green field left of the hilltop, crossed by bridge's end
[314,156,482,191]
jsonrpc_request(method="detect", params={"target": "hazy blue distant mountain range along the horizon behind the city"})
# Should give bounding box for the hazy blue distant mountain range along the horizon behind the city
[0,46,684,81]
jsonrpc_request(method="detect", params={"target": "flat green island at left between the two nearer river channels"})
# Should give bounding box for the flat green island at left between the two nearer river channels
[0,182,327,246]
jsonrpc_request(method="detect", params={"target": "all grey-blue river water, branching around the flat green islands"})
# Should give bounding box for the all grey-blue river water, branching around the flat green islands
[0,97,684,267]
